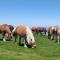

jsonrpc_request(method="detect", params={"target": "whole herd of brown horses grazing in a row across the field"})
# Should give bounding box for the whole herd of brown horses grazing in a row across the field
[0,24,60,48]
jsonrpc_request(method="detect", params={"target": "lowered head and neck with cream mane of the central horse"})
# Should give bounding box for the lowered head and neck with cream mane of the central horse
[26,27,36,48]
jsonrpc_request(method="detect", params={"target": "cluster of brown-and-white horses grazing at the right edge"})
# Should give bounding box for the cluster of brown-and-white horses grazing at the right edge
[48,26,60,43]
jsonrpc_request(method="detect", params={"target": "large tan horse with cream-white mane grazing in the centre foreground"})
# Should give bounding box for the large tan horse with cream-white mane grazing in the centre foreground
[13,25,36,48]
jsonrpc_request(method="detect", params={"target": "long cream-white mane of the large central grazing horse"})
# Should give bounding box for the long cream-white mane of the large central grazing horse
[26,26,35,44]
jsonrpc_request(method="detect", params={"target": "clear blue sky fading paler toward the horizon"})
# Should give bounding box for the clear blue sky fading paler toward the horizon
[0,0,60,26]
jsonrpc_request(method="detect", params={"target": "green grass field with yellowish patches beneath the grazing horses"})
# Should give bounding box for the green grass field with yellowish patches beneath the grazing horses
[0,36,60,60]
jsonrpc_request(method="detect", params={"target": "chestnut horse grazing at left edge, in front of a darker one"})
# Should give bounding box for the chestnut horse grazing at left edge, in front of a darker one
[0,24,12,41]
